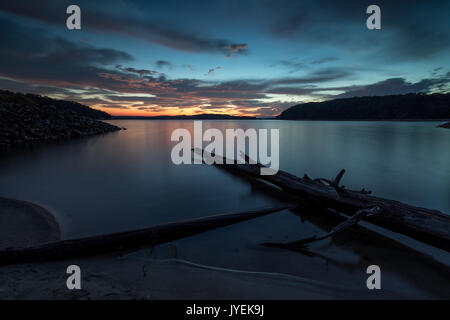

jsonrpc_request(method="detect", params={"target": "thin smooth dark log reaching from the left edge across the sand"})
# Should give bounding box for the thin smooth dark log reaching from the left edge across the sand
[0,205,295,265]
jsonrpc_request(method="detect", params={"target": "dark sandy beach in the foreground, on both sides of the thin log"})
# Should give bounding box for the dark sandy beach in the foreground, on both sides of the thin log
[0,198,448,300]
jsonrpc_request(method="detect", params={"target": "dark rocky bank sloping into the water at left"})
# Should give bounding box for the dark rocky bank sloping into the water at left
[0,102,121,148]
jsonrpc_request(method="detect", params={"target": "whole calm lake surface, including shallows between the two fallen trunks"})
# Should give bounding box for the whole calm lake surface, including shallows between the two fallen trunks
[0,120,450,297]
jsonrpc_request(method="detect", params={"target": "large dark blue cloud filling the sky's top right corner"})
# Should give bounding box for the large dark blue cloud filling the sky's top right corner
[266,0,450,62]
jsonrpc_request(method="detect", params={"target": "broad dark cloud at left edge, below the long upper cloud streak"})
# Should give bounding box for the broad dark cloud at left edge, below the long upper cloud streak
[0,18,133,86]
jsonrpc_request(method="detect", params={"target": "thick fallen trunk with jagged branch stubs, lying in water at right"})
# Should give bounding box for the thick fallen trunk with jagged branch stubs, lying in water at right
[194,150,450,252]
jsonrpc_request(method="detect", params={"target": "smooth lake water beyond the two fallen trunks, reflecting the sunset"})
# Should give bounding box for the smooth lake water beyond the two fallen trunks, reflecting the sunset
[0,120,450,237]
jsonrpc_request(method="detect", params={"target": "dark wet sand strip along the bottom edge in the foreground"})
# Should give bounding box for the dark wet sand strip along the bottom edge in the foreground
[0,255,404,300]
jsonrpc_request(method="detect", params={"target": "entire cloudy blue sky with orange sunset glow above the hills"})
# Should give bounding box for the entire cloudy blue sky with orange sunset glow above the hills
[0,0,450,117]
